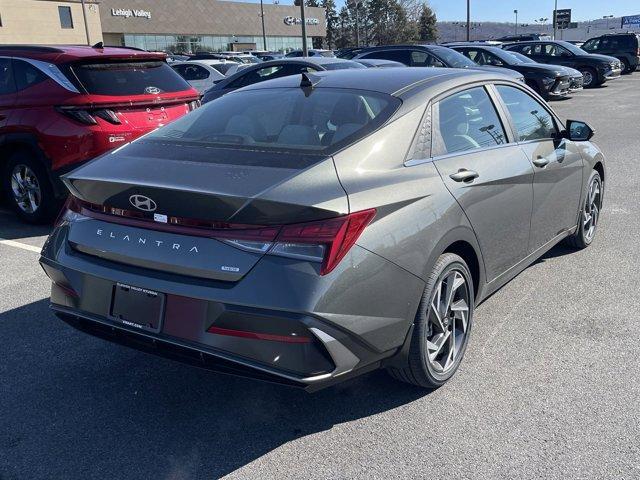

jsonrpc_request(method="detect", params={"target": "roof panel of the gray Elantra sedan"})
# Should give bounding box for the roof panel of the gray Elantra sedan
[238,67,516,97]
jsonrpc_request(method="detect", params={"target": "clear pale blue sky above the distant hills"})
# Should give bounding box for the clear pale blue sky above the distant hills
[428,0,640,23]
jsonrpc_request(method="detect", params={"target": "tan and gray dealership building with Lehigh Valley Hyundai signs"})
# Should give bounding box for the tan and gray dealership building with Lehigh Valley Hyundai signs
[0,0,326,52]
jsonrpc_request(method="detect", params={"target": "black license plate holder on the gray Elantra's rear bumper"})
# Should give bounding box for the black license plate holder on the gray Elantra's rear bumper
[110,282,165,333]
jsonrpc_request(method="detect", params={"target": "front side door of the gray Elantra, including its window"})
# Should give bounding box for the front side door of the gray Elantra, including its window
[495,85,583,251]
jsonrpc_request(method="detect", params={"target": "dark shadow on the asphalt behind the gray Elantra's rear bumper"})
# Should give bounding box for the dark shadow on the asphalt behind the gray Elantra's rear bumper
[0,300,428,479]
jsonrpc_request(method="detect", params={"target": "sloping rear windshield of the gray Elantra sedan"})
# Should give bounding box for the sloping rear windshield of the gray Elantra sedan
[147,88,401,153]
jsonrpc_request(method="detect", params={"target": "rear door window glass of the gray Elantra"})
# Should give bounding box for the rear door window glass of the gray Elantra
[435,87,506,154]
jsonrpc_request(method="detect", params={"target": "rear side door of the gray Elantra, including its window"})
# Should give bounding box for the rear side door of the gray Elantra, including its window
[432,86,533,281]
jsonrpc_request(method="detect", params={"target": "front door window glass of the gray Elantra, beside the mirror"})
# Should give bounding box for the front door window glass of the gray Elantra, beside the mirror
[496,85,556,141]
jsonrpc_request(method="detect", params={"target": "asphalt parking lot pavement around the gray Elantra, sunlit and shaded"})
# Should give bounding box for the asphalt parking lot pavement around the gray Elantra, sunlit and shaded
[0,72,640,480]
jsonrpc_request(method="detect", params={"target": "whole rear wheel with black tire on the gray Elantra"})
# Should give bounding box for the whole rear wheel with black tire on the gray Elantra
[388,253,475,389]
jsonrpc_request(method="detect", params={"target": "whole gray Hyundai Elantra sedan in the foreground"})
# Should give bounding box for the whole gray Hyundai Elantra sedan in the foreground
[41,68,606,390]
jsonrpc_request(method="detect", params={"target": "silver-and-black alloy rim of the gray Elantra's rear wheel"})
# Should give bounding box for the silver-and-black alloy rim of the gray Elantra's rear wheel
[427,269,470,375]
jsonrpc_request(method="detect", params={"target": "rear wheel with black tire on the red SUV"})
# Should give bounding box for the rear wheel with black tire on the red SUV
[0,150,62,224]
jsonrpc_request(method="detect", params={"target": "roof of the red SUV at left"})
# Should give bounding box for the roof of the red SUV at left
[0,45,167,63]
